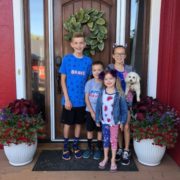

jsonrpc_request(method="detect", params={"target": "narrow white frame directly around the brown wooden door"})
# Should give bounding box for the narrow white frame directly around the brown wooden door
[48,0,126,141]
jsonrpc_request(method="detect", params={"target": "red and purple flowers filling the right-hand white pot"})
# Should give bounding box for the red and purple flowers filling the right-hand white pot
[130,97,180,148]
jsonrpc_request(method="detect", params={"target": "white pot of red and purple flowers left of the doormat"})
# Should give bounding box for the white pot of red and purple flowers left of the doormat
[0,99,45,166]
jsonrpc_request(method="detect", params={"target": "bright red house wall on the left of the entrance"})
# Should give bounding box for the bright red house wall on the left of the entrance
[0,0,16,108]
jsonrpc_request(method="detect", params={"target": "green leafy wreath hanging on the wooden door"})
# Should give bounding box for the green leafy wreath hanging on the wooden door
[63,9,107,56]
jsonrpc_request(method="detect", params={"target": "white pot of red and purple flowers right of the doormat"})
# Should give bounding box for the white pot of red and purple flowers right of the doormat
[131,96,180,166]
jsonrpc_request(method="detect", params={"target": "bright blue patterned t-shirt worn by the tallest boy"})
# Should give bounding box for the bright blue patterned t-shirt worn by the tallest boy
[59,54,92,107]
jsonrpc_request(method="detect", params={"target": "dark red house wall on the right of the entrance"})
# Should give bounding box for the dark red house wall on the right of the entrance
[157,0,180,165]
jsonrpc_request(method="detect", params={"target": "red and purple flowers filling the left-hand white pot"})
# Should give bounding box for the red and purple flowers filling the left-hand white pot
[0,99,45,145]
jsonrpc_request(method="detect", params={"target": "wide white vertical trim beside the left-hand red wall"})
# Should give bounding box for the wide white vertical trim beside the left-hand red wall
[12,0,26,99]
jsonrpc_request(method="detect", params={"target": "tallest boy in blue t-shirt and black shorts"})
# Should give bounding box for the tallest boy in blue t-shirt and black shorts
[59,33,92,160]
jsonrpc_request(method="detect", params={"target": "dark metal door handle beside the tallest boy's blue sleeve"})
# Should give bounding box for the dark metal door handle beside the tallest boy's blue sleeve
[55,56,62,94]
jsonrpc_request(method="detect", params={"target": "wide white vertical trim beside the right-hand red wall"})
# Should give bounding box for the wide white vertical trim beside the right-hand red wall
[147,0,161,98]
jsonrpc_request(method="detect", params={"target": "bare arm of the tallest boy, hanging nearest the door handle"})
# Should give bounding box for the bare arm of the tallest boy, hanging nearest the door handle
[61,74,72,110]
